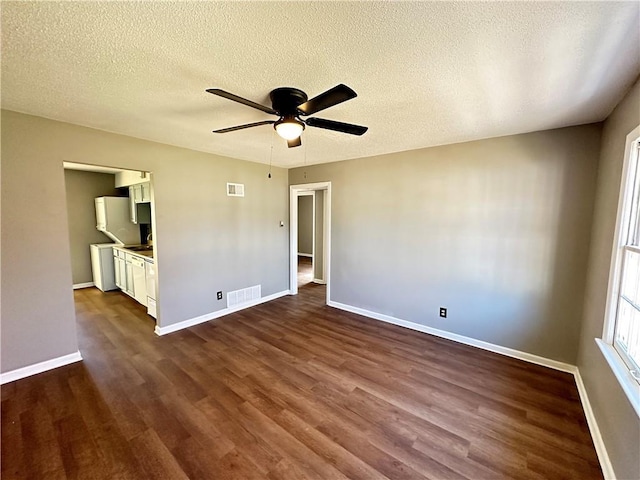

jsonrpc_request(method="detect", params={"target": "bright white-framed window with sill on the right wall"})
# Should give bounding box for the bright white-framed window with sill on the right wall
[597,126,640,416]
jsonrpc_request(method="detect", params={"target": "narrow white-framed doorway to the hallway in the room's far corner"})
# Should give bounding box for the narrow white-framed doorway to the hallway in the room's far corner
[289,182,331,302]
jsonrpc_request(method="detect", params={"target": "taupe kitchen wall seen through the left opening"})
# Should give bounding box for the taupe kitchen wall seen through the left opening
[64,170,120,285]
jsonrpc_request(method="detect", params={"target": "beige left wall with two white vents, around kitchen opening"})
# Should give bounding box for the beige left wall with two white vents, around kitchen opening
[0,110,289,372]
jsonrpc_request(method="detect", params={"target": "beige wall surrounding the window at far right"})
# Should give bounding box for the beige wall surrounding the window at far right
[578,77,640,479]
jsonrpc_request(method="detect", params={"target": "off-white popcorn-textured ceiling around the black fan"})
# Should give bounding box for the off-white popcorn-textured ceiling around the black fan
[2,1,640,167]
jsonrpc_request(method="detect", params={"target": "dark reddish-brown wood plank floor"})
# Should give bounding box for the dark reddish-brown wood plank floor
[2,284,602,480]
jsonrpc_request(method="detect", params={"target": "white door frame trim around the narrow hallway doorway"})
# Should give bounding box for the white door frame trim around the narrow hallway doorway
[289,182,331,304]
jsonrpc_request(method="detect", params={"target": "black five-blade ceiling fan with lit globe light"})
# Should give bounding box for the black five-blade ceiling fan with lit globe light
[207,84,368,148]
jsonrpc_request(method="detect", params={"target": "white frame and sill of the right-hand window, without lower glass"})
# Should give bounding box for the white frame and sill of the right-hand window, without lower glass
[596,125,640,417]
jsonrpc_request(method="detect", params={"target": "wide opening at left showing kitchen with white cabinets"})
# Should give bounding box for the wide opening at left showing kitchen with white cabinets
[63,162,158,326]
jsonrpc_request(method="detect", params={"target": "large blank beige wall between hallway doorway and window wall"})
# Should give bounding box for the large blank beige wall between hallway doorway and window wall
[289,125,601,364]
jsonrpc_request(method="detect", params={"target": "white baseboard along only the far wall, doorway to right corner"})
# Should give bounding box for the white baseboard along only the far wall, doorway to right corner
[327,301,576,373]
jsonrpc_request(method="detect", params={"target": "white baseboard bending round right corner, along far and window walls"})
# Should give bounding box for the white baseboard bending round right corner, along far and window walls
[327,301,616,480]
